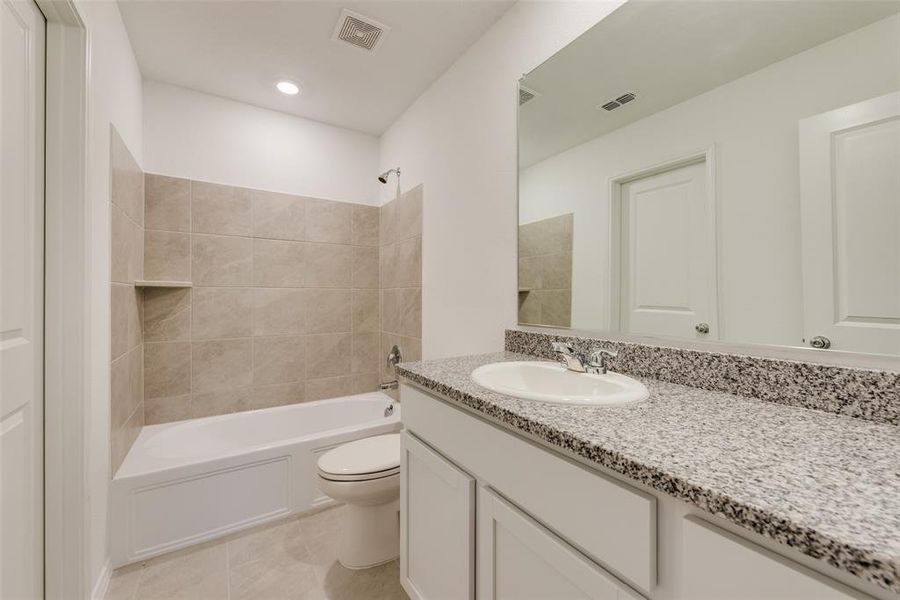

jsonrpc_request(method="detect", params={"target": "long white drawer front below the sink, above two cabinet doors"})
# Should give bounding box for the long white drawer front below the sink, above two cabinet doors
[401,385,656,592]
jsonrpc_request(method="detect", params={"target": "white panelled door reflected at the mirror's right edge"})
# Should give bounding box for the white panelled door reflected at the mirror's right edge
[800,92,900,355]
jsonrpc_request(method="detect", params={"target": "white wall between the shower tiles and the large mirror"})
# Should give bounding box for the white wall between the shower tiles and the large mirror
[380,1,621,358]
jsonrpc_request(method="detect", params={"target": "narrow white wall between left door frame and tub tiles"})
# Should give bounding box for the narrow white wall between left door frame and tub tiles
[77,0,142,585]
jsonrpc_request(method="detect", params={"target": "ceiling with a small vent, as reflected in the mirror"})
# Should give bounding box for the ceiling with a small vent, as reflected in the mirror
[519,0,900,167]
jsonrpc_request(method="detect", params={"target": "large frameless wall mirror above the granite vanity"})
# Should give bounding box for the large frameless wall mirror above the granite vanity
[518,0,900,356]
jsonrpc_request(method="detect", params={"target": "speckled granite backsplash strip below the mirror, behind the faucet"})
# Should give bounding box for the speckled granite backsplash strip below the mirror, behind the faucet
[505,329,900,425]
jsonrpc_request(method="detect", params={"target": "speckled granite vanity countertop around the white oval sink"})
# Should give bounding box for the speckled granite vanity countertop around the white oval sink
[397,352,900,593]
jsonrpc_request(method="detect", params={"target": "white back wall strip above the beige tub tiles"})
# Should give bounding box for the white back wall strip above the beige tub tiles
[143,81,380,204]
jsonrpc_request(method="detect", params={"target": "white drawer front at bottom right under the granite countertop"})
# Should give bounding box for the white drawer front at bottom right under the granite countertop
[683,516,872,600]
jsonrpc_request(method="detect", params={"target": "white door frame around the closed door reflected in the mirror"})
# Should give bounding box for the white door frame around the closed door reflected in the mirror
[607,144,723,340]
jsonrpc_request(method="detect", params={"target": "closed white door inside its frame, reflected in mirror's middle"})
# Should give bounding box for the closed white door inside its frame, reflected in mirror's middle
[619,161,718,339]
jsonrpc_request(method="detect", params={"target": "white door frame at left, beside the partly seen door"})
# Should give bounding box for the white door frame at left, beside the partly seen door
[35,0,92,598]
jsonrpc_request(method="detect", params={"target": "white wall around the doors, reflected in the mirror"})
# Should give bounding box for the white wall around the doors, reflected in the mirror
[519,16,900,345]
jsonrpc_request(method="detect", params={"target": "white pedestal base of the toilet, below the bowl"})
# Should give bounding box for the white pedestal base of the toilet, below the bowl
[338,500,400,570]
